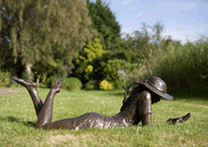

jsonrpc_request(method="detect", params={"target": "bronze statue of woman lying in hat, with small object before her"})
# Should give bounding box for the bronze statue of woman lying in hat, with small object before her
[11,76,190,130]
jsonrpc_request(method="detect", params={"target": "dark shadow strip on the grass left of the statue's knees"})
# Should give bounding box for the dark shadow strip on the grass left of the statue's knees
[0,116,35,127]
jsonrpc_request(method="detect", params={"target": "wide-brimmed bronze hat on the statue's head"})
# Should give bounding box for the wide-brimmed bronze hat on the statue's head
[137,76,173,100]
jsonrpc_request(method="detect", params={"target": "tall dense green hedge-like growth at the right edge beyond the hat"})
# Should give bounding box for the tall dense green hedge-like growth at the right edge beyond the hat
[152,42,208,89]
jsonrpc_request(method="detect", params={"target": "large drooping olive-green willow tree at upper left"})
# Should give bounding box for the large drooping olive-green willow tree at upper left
[0,0,91,80]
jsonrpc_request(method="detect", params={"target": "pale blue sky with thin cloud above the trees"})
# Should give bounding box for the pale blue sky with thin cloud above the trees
[91,0,208,43]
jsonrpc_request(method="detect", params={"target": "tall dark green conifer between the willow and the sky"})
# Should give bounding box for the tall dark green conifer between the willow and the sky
[87,0,121,49]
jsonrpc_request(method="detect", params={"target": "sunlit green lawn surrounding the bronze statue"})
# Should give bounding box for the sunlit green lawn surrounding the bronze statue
[0,88,208,147]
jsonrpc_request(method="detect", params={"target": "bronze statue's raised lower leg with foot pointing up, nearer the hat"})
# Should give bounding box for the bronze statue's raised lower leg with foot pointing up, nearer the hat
[36,78,62,127]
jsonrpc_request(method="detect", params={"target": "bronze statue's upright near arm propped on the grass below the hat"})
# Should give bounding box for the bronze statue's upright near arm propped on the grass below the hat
[139,94,152,126]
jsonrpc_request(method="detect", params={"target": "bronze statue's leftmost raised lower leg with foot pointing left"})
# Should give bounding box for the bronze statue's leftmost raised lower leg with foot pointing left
[10,76,43,116]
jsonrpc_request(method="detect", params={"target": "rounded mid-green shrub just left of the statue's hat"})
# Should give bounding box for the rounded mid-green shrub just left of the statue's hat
[104,59,139,89]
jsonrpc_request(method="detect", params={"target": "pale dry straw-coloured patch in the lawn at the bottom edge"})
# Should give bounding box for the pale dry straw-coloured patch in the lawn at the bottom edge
[46,134,95,146]
